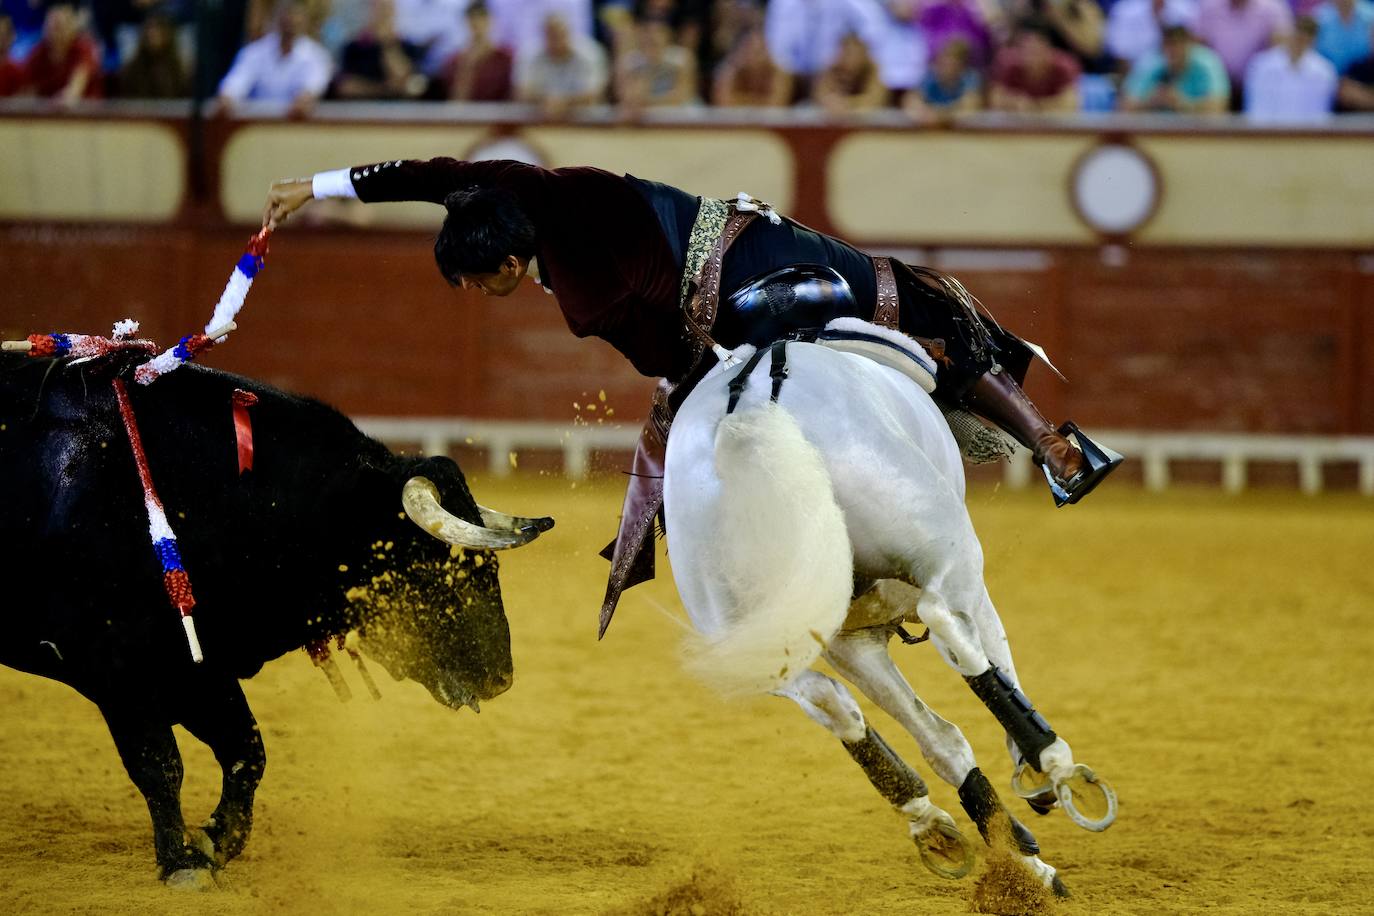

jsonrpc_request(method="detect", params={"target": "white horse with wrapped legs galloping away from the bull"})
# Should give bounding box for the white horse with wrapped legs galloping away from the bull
[664,320,1116,894]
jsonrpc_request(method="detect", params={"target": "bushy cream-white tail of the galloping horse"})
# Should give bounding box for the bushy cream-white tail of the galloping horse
[688,404,853,694]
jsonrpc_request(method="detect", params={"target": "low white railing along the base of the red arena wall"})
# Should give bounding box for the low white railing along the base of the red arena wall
[357,417,1374,496]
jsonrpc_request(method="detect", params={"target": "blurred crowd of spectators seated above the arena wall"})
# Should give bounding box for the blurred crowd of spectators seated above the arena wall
[0,0,1374,121]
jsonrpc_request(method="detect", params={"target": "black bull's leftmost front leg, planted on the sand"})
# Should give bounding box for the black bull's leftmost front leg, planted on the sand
[100,702,213,887]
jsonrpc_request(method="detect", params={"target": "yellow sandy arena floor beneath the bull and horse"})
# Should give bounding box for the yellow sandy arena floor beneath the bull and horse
[0,477,1374,916]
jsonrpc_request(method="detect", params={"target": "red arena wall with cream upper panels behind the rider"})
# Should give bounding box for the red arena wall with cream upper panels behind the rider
[0,111,1374,434]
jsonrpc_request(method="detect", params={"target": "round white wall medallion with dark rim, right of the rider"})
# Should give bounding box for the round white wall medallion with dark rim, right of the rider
[1069,143,1161,236]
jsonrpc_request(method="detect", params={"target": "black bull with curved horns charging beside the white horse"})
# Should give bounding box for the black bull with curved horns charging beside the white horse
[0,354,551,878]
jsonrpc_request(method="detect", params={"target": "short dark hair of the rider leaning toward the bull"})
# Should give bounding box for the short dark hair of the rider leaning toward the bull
[434,188,534,286]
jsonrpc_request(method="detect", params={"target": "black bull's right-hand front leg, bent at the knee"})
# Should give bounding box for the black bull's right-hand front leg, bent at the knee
[181,680,267,865]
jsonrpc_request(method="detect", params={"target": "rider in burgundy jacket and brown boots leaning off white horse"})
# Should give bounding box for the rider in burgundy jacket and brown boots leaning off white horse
[264,158,1120,633]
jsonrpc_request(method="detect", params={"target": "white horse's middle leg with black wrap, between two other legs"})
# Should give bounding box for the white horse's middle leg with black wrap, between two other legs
[826,626,1068,897]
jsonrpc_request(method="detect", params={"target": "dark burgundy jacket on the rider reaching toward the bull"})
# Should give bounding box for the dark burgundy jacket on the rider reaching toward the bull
[349,158,691,379]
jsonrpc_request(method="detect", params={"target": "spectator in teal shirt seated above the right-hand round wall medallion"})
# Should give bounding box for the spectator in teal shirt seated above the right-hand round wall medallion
[1121,26,1231,114]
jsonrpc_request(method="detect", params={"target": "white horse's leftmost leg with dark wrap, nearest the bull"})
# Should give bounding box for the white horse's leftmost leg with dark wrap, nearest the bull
[778,670,973,878]
